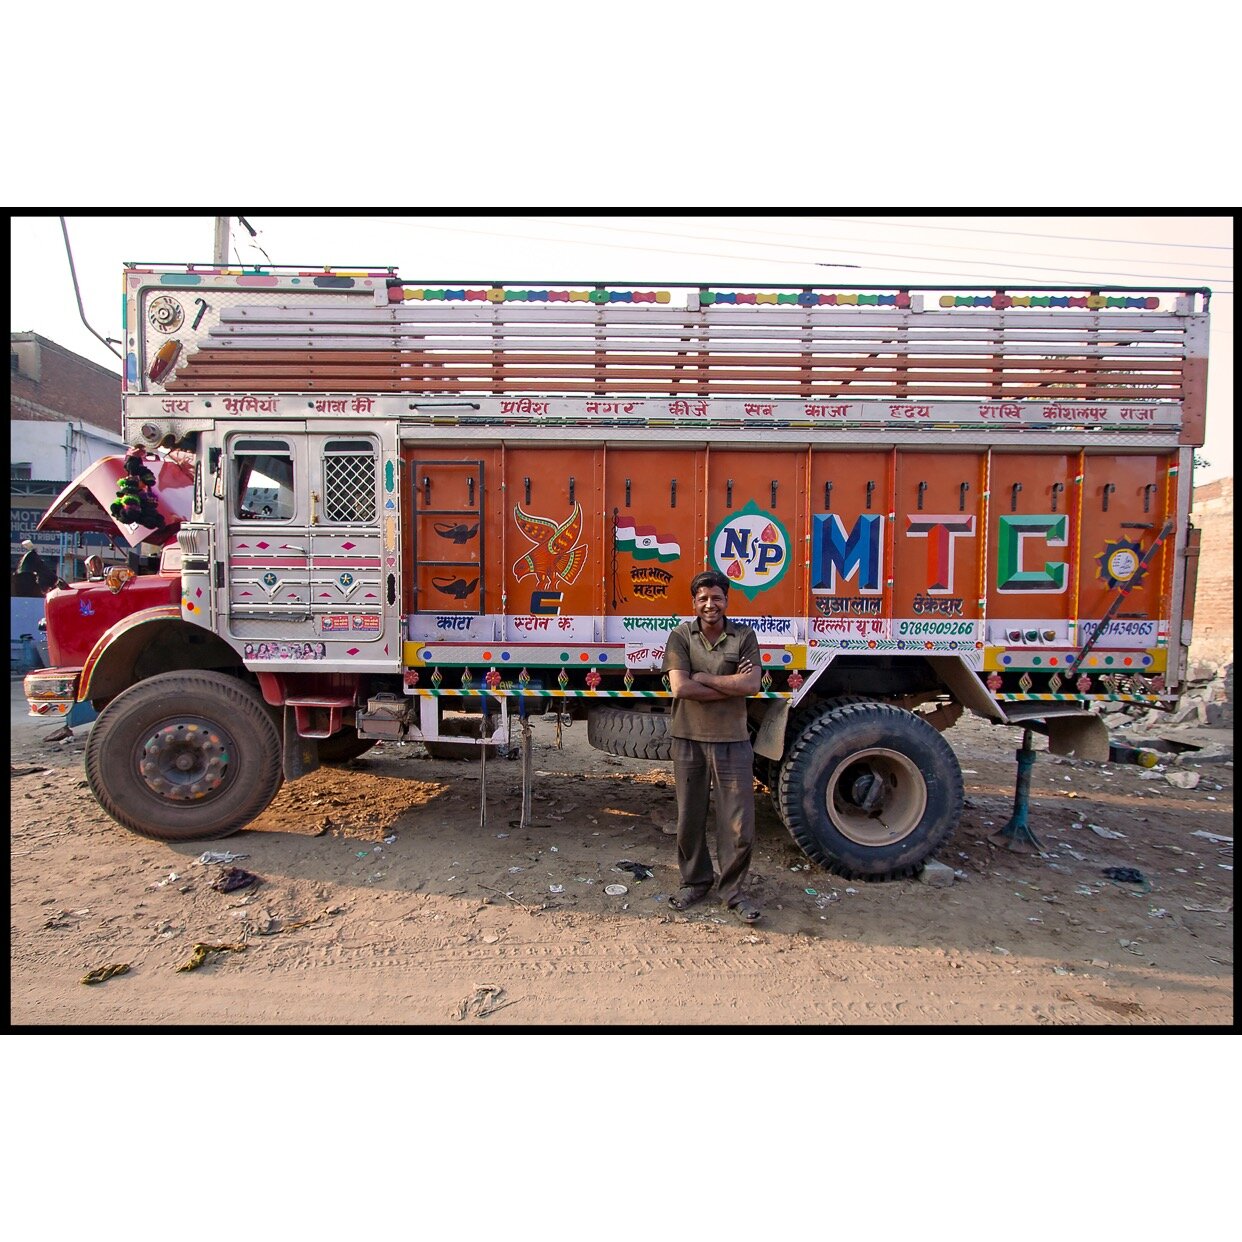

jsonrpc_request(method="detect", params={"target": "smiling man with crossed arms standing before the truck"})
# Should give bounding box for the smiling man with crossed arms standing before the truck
[663,570,760,923]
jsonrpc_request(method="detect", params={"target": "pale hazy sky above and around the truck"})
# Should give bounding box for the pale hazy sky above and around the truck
[10,211,1233,483]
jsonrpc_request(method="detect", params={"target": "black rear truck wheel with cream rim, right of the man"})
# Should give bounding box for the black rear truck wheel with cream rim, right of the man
[776,702,963,879]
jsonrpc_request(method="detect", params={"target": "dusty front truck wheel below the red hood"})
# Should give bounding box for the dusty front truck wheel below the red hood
[86,672,281,841]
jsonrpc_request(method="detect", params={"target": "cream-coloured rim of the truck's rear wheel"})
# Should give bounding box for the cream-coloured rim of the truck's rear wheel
[825,746,928,846]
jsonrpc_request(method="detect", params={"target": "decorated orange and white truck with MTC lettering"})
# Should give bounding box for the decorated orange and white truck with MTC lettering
[26,265,1210,878]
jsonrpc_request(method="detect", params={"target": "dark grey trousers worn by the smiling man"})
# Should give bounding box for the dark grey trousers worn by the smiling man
[673,738,755,905]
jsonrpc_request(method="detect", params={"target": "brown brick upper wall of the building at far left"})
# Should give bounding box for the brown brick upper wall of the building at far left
[9,332,120,435]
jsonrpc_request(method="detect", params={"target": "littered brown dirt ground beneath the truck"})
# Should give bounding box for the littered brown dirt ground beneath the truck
[10,683,1233,1028]
